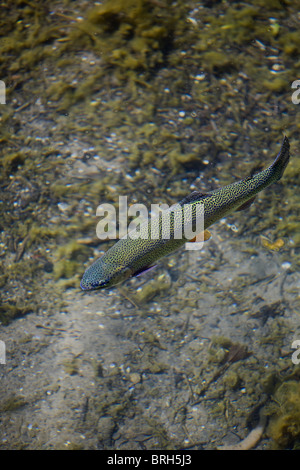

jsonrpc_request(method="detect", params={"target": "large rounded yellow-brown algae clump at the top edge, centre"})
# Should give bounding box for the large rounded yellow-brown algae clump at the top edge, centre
[80,0,189,70]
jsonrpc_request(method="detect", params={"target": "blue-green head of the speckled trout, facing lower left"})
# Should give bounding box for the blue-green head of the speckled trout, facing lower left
[80,258,132,290]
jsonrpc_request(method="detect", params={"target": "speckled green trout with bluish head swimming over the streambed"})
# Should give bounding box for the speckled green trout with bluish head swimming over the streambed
[80,136,290,291]
